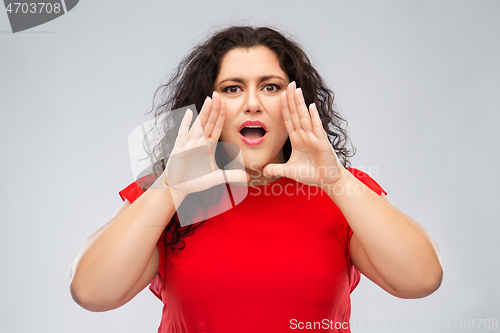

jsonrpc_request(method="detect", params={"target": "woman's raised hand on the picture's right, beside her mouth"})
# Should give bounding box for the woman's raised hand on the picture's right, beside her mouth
[263,82,348,188]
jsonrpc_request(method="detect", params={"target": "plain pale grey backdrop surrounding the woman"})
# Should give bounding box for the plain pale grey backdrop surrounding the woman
[0,0,500,333]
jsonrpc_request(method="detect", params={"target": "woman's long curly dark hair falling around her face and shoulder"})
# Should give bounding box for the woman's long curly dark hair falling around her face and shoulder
[139,26,356,249]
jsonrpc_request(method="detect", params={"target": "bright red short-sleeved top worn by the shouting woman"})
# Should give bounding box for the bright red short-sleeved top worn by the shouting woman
[120,168,387,333]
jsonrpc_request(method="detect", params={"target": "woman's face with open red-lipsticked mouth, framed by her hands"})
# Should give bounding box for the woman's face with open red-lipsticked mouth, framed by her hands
[214,46,289,182]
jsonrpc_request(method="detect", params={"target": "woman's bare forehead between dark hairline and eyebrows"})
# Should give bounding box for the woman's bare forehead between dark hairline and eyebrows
[218,46,288,80]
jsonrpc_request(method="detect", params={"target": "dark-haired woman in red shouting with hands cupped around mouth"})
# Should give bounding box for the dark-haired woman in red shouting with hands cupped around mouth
[71,27,442,332]
